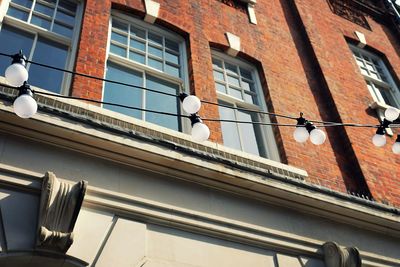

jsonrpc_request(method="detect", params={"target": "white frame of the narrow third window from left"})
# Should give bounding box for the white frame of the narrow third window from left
[211,50,280,161]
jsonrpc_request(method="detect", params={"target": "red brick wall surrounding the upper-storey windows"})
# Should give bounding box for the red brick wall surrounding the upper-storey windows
[72,0,400,206]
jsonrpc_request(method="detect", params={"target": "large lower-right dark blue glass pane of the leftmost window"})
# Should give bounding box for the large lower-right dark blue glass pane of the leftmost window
[29,37,68,93]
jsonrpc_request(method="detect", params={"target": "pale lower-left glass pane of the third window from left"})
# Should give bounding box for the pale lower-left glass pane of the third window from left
[218,102,241,150]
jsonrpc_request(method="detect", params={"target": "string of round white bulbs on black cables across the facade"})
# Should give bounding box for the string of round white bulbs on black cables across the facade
[0,51,400,154]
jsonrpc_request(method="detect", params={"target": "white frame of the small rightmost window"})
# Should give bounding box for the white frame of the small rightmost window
[350,45,400,108]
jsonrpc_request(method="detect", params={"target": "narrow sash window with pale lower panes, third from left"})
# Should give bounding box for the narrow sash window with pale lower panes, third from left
[212,52,279,160]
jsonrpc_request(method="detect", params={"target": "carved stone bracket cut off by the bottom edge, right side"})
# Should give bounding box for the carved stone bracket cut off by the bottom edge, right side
[322,242,361,267]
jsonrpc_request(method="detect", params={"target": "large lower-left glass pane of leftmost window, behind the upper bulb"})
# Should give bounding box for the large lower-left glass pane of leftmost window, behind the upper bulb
[0,24,35,76]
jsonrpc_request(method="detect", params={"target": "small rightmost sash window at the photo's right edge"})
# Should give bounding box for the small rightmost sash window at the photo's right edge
[350,46,400,108]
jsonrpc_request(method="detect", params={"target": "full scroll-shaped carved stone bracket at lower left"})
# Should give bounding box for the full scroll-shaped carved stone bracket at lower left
[36,172,87,253]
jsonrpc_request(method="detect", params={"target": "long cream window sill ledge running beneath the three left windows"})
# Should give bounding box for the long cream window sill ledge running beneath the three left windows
[0,82,308,180]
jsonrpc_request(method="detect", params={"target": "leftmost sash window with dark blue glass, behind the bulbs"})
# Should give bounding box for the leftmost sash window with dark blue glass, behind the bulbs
[0,0,81,93]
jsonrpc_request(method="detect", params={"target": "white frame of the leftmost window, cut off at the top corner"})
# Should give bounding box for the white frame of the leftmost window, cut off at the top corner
[0,0,83,95]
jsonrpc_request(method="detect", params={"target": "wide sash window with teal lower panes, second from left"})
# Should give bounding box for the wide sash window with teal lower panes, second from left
[103,14,187,131]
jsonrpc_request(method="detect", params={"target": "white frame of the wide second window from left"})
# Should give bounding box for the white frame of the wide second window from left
[102,10,191,133]
